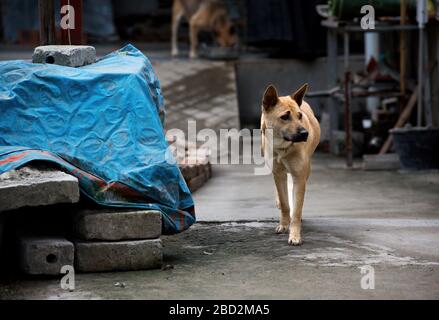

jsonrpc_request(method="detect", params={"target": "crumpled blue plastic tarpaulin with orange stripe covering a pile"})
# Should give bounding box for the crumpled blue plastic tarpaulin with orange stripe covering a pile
[0,45,195,234]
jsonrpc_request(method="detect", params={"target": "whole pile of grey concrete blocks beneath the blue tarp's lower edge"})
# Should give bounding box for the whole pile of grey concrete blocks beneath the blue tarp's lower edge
[0,167,163,275]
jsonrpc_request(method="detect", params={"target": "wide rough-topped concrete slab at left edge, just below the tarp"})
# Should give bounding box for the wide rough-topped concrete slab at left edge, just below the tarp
[0,167,79,212]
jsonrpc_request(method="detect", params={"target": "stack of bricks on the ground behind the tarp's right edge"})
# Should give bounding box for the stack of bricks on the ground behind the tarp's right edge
[167,137,212,192]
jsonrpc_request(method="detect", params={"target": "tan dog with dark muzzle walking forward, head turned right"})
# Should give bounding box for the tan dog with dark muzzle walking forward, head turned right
[261,84,320,245]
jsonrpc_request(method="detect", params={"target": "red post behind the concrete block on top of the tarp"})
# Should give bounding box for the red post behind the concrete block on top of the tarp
[60,0,84,45]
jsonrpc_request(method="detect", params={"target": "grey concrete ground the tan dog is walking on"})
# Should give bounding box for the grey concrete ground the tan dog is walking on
[0,154,439,299]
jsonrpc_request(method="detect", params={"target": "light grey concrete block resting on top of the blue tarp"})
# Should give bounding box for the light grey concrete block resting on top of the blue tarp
[32,46,96,67]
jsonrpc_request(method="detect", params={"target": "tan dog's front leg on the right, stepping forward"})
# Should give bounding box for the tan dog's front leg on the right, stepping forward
[288,177,306,246]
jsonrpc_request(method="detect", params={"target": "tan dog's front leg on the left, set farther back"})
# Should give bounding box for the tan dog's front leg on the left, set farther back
[273,169,290,233]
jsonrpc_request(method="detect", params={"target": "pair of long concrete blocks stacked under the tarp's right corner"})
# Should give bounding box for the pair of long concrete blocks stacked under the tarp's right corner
[73,209,163,272]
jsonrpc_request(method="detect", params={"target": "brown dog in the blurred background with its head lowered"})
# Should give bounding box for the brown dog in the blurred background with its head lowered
[171,0,237,58]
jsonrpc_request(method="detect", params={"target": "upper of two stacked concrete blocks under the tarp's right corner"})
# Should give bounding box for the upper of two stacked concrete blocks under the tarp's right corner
[73,209,162,241]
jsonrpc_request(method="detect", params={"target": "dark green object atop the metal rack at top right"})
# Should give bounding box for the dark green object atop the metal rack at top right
[328,0,416,20]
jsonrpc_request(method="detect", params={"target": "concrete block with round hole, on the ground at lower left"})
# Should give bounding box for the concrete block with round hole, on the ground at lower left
[19,237,75,275]
